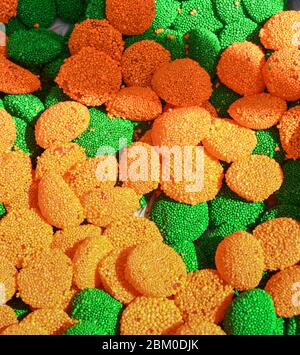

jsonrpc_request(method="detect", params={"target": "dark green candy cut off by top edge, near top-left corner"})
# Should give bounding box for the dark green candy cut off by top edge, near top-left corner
[18,0,56,27]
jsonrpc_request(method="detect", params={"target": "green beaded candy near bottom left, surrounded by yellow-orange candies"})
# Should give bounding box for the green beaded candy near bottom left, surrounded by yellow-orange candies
[70,288,123,335]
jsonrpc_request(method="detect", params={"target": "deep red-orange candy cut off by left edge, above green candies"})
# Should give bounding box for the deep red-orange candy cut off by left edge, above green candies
[0,55,41,94]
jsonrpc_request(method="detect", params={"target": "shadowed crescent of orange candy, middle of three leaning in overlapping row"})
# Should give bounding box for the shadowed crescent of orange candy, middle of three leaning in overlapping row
[98,248,140,304]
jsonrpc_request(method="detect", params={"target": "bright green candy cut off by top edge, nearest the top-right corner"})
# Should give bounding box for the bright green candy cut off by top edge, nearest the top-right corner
[243,0,287,23]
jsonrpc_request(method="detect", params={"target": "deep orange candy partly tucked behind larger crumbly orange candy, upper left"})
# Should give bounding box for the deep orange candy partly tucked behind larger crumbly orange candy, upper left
[69,19,124,61]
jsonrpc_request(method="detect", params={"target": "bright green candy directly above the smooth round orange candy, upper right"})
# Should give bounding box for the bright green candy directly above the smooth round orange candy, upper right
[219,18,260,49]
